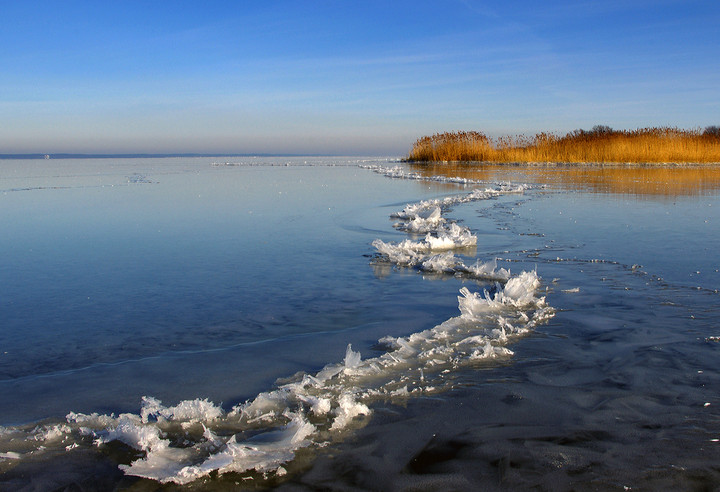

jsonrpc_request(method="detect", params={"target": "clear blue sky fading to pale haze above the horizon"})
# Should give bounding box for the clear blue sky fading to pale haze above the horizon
[0,0,720,155]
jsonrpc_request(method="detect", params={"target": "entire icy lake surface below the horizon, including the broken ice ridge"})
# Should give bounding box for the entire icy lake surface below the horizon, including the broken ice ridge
[0,158,720,490]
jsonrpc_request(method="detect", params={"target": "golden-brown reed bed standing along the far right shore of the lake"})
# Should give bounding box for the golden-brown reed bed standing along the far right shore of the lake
[408,126,720,163]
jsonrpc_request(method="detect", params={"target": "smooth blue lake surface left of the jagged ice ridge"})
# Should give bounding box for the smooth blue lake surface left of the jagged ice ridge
[0,158,462,424]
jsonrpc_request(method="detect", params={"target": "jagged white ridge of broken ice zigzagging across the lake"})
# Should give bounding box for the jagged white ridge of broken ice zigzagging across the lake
[0,176,554,484]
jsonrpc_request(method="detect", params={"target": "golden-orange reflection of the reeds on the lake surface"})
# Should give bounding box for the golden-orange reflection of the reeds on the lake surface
[411,163,720,197]
